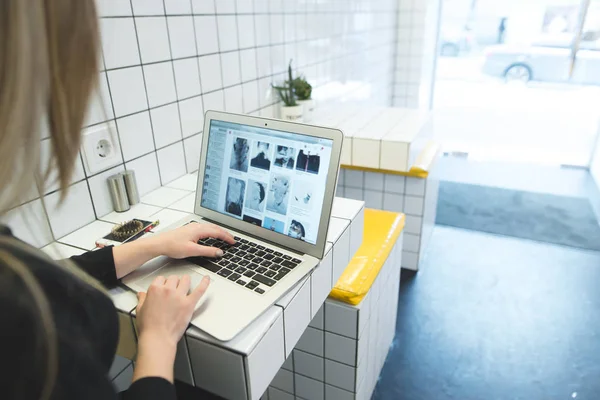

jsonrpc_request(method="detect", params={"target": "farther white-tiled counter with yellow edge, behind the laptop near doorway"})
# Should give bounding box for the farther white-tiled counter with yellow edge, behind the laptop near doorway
[310,104,439,271]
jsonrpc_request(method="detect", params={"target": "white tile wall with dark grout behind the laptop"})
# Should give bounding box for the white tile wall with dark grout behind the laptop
[7,0,397,250]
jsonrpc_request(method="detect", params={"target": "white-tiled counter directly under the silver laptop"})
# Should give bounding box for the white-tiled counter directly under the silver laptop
[44,174,364,399]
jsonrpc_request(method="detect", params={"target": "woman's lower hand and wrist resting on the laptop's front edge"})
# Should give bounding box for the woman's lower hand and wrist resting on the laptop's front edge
[133,275,210,382]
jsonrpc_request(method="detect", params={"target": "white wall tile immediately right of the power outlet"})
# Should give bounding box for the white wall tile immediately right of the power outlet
[117,111,154,161]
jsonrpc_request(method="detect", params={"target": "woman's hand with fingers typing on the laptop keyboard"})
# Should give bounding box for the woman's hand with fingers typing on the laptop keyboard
[149,223,235,258]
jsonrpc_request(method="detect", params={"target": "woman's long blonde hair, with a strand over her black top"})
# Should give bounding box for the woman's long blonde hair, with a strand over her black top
[0,0,100,399]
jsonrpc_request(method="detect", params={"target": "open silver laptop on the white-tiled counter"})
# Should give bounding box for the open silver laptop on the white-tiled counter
[124,111,343,341]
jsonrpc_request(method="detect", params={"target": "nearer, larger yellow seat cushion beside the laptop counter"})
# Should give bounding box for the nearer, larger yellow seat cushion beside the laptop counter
[329,208,405,305]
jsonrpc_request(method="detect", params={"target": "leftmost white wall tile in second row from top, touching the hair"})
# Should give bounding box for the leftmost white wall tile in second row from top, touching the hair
[100,18,140,69]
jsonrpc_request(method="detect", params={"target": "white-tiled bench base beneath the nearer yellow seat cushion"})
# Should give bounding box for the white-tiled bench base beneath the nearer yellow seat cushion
[268,211,402,400]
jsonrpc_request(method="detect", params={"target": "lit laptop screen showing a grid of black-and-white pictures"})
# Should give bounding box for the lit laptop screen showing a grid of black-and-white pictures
[201,120,333,244]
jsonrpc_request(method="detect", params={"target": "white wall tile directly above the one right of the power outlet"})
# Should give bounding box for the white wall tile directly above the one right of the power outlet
[108,67,148,117]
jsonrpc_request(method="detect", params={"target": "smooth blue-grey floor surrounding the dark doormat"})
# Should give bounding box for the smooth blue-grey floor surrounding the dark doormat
[373,158,600,400]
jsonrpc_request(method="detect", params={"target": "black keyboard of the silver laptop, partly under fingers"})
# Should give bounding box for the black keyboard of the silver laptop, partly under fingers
[188,236,302,294]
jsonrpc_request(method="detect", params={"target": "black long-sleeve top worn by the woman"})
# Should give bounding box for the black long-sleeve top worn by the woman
[0,226,176,400]
